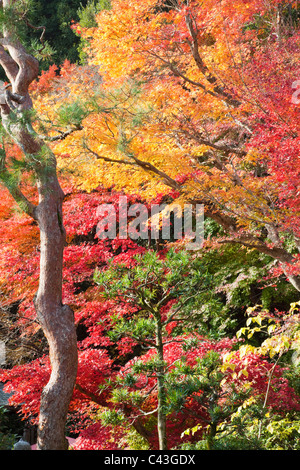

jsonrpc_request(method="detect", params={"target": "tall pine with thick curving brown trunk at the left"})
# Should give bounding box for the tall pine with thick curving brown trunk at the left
[0,0,77,450]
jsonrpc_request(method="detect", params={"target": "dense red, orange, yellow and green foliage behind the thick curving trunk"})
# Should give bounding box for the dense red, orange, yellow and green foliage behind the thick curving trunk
[0,0,300,450]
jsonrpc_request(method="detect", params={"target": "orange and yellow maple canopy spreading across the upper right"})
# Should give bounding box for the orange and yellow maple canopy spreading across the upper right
[52,0,300,291]
